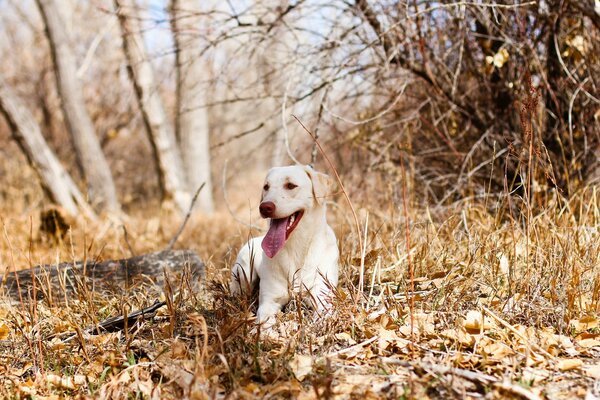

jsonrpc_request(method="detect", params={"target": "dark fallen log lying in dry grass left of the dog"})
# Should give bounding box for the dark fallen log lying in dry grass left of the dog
[0,250,205,300]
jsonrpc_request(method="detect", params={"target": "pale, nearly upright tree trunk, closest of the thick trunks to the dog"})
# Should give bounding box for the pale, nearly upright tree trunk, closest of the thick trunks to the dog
[171,0,214,213]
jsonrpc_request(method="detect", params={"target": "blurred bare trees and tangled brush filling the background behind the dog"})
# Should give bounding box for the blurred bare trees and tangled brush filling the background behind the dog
[0,0,600,219]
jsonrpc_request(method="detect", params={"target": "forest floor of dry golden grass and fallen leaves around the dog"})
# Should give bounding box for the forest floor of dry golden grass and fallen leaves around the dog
[0,179,600,399]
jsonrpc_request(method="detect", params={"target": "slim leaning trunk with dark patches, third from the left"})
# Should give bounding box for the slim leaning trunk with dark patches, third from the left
[114,0,191,213]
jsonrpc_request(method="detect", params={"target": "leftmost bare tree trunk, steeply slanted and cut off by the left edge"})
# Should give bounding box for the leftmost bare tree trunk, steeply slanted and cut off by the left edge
[0,77,94,217]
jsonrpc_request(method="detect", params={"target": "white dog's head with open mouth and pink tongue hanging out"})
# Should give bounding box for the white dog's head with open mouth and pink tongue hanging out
[259,165,332,258]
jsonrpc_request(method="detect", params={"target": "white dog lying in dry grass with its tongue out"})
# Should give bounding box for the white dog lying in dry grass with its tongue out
[230,165,339,327]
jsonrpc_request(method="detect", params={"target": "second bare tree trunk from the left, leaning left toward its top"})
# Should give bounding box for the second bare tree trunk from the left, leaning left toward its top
[36,0,120,212]
